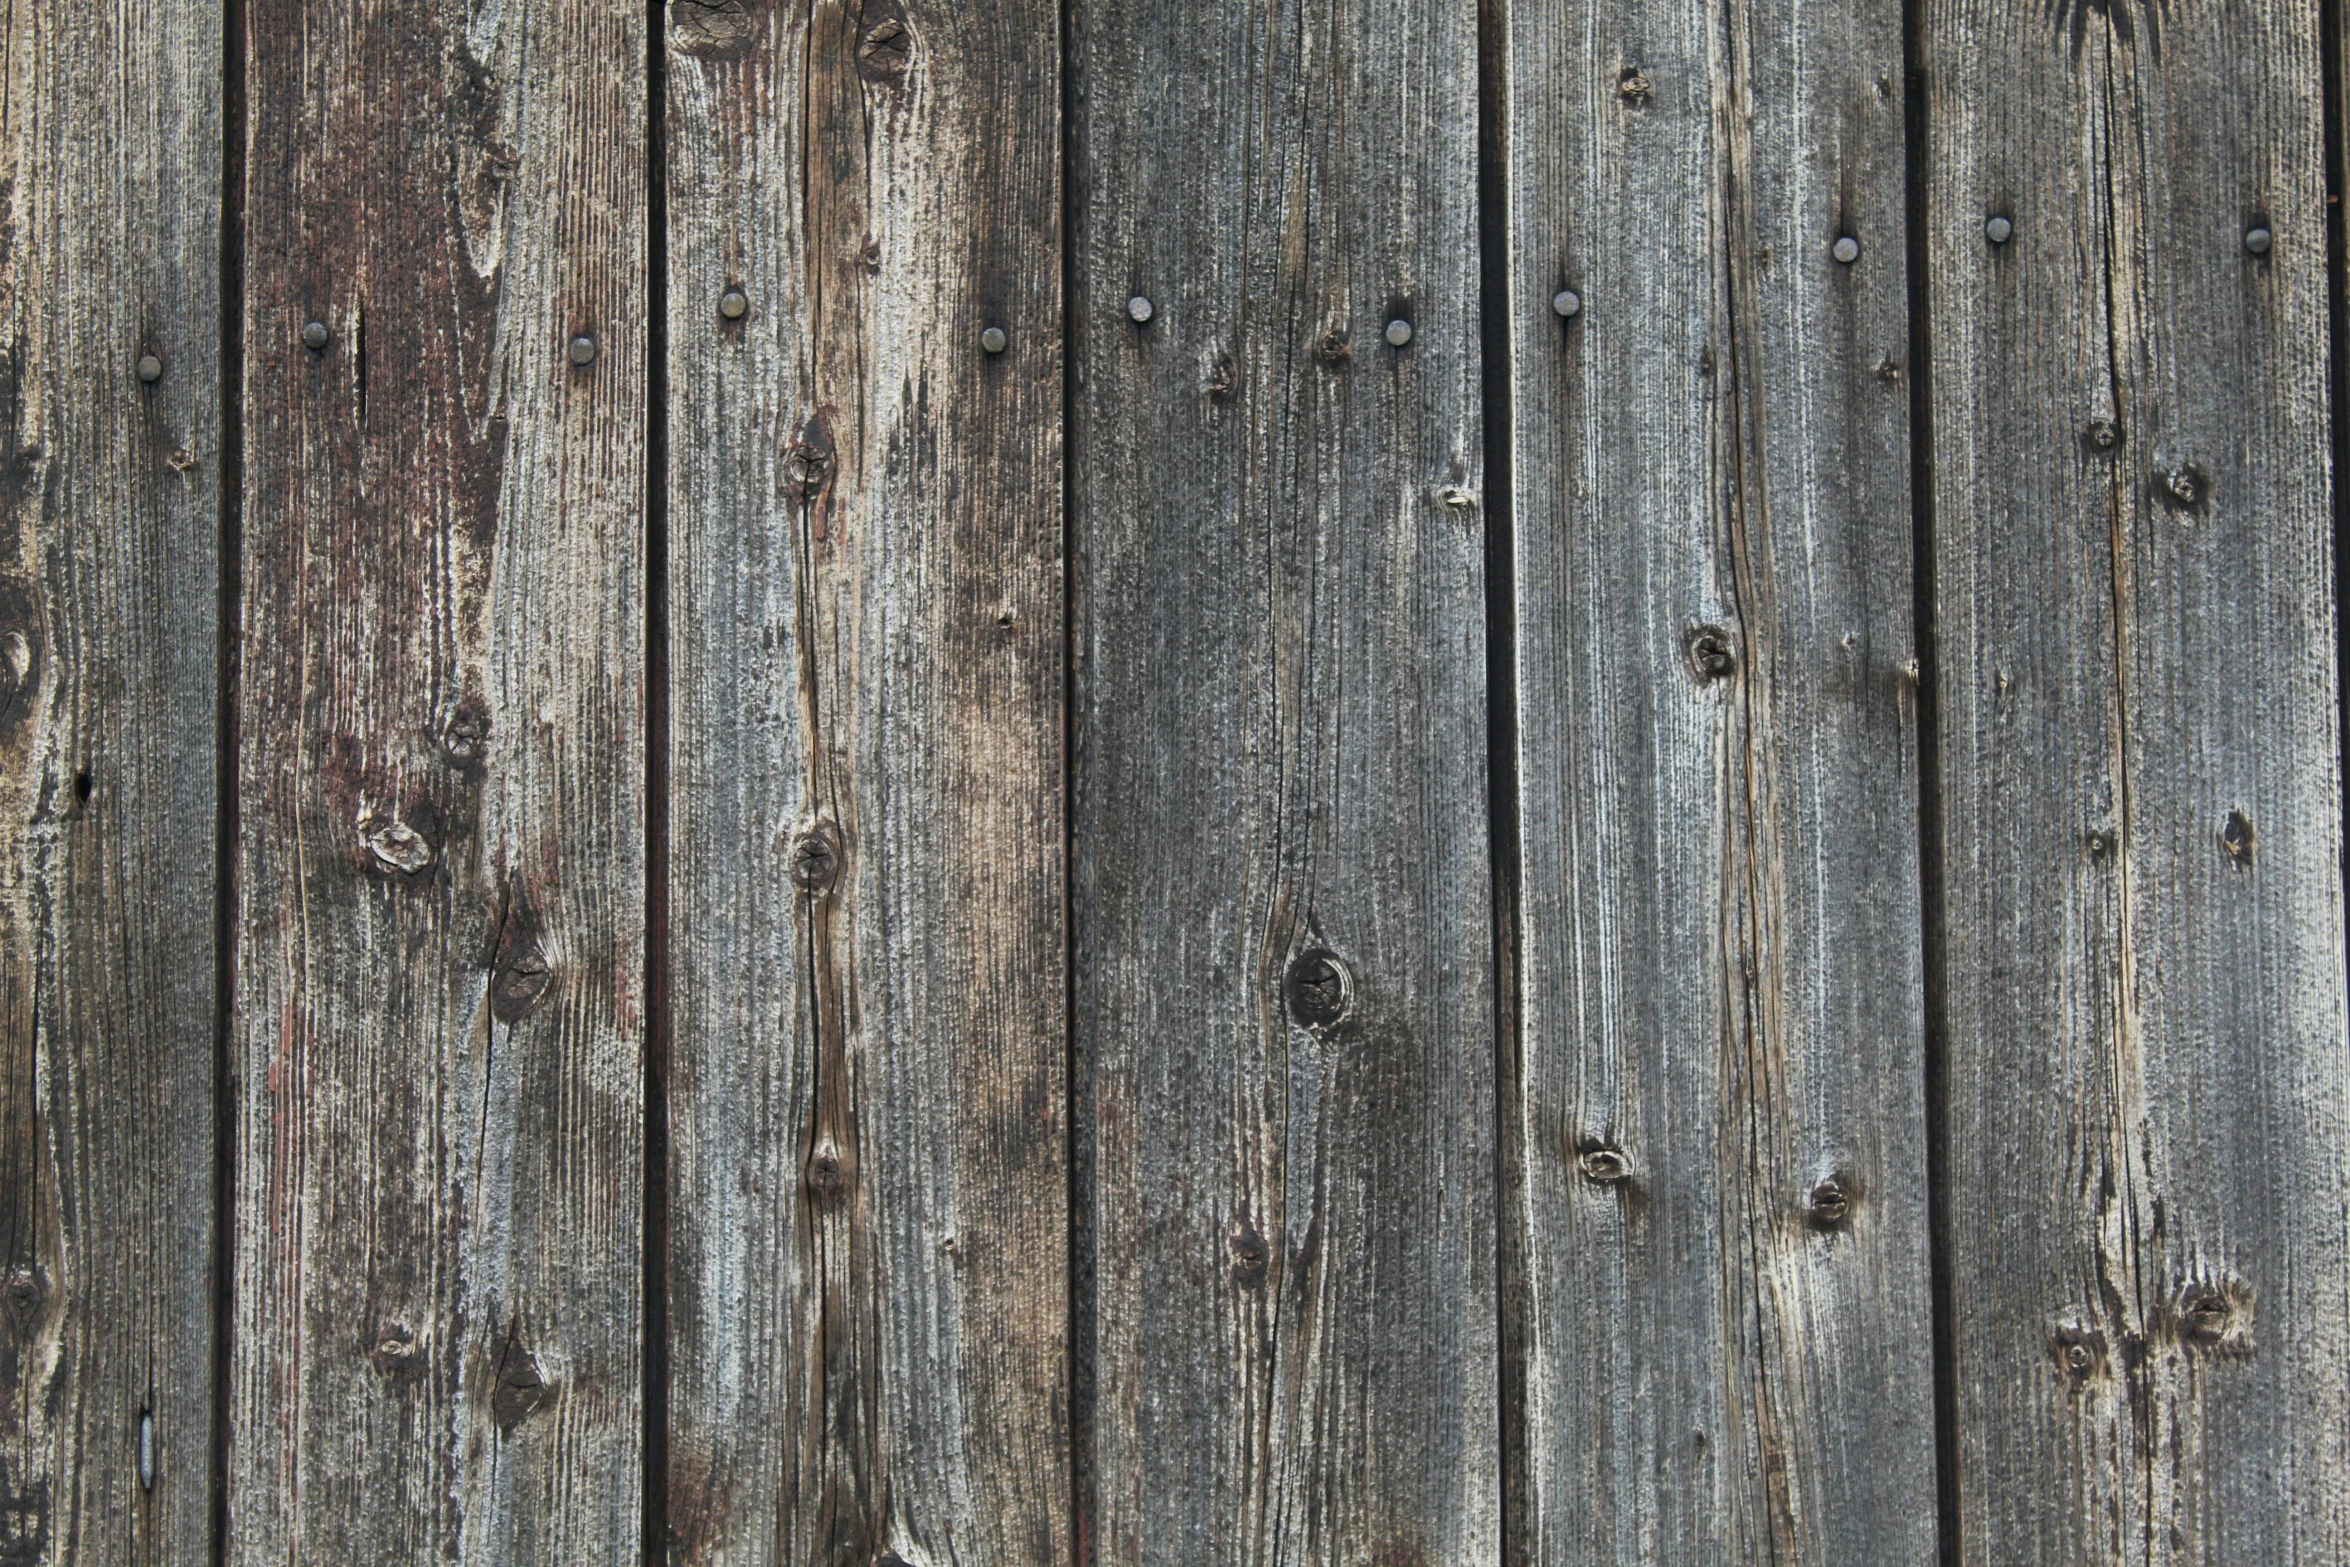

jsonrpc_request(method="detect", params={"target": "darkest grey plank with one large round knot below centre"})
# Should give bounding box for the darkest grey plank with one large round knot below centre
[1072,0,1499,1567]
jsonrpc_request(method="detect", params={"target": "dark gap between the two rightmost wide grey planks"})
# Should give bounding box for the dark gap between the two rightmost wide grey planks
[1901,0,1962,1567]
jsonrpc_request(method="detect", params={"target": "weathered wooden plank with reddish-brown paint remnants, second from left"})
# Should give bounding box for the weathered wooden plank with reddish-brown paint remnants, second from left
[228,0,646,1562]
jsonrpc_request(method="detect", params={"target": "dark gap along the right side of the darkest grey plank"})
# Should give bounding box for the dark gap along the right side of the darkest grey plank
[1476,0,1535,1567]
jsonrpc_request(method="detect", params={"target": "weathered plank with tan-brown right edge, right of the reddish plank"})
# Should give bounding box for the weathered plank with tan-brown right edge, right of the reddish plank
[667,0,1072,1567]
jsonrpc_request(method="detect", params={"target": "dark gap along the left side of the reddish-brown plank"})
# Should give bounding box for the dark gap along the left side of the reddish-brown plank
[209,0,249,1567]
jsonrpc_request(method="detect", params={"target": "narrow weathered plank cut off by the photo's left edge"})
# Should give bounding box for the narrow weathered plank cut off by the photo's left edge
[0,5,221,1562]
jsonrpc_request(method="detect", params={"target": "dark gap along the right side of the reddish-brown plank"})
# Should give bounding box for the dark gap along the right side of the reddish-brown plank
[642,0,670,1567]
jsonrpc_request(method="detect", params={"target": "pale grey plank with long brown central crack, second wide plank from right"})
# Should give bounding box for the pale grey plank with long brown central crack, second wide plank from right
[1502,0,1934,1562]
